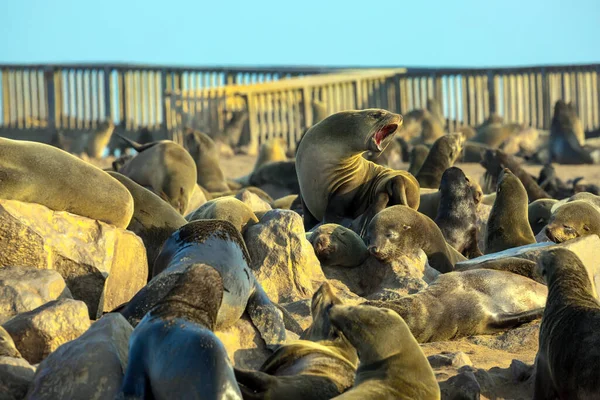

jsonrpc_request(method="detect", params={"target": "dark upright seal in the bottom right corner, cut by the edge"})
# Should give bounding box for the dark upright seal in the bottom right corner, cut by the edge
[533,248,600,400]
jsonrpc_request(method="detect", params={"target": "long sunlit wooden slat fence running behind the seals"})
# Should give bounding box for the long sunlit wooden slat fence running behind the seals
[0,64,600,150]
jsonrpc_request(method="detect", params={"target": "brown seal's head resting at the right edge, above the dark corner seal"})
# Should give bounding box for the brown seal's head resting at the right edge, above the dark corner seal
[546,200,600,243]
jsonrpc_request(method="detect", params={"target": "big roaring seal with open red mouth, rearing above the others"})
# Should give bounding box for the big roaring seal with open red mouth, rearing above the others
[296,109,419,236]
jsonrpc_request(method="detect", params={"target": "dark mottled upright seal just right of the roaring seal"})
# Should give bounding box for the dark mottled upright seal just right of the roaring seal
[434,167,483,258]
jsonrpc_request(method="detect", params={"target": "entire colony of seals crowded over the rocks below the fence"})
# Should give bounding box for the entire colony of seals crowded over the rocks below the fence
[0,99,600,400]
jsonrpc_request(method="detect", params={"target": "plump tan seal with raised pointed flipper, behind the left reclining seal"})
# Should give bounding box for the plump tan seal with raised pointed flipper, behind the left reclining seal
[117,134,196,214]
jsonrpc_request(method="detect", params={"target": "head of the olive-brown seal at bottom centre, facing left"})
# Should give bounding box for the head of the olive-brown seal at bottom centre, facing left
[329,305,414,364]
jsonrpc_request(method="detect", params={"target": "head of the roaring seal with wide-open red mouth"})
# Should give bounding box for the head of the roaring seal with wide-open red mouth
[306,108,402,154]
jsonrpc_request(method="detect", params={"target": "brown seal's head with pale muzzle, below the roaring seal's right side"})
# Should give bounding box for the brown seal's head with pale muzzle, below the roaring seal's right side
[367,206,424,262]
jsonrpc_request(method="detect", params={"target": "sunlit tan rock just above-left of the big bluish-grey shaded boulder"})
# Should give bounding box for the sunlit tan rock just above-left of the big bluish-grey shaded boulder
[2,299,90,364]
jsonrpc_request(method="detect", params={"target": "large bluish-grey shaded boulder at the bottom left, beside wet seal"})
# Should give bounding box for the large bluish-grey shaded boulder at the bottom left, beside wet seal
[27,313,133,400]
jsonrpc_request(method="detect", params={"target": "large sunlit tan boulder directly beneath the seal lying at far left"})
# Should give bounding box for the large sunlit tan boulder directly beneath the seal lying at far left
[0,200,148,319]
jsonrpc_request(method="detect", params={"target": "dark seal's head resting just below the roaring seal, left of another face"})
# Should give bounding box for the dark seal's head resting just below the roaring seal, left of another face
[307,224,369,267]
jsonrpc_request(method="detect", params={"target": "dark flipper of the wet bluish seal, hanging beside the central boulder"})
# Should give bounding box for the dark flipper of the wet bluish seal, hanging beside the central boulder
[246,280,286,349]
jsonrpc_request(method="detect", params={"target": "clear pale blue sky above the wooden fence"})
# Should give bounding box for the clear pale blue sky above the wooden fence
[0,0,600,67]
